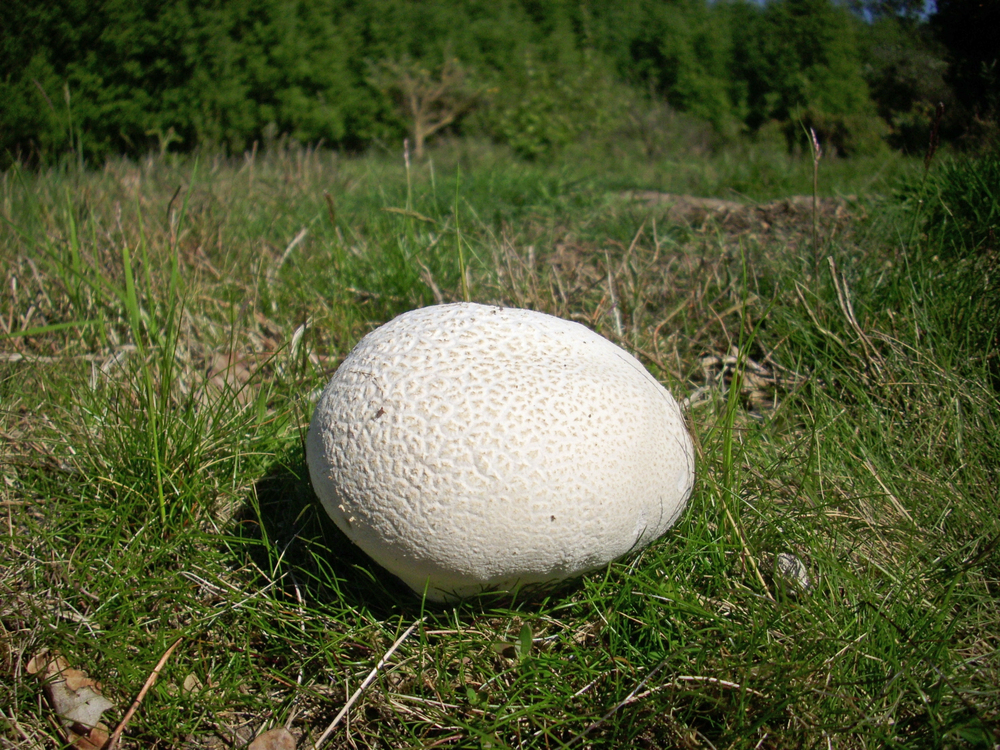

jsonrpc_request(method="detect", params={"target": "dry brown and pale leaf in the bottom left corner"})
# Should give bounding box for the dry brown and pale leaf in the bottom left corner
[26,651,115,750]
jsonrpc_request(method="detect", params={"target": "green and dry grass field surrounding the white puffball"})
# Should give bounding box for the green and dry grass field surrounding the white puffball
[0,138,1000,748]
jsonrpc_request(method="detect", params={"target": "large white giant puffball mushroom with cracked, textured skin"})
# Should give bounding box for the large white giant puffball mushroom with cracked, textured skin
[306,303,694,601]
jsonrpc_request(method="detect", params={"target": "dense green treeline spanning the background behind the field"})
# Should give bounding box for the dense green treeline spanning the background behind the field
[0,0,1000,166]
